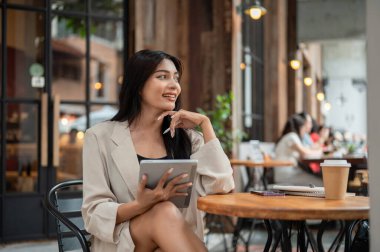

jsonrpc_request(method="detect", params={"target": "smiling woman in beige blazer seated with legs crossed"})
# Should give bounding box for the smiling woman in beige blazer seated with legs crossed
[82,50,234,252]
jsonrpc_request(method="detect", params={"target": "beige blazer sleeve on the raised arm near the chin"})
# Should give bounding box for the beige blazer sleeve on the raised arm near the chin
[190,130,235,196]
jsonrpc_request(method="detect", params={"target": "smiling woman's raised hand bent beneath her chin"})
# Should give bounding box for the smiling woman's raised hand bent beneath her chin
[157,109,210,137]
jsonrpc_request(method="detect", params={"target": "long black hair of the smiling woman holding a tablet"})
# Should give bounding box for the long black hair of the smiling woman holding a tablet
[111,50,191,159]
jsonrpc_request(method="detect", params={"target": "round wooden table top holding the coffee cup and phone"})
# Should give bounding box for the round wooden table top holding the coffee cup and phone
[198,193,369,220]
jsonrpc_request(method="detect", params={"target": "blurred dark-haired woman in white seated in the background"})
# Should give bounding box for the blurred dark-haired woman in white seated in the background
[274,115,323,186]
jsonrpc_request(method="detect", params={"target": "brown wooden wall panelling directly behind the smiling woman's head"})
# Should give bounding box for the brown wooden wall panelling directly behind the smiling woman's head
[134,0,233,110]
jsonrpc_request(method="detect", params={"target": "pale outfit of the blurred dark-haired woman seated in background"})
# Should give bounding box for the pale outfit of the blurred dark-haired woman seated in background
[274,132,323,186]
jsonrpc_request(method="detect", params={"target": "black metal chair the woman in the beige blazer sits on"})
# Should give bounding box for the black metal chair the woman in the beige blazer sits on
[45,180,91,252]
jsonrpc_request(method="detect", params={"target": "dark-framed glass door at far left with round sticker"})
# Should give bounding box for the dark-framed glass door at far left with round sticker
[0,1,47,241]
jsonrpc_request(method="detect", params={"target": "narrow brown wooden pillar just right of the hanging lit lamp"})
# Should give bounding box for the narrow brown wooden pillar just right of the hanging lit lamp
[264,0,287,141]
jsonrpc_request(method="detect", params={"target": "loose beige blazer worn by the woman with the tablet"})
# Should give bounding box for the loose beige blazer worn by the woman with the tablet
[82,121,234,252]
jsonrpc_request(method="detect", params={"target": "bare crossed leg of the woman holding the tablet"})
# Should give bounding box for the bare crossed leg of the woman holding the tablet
[129,201,207,252]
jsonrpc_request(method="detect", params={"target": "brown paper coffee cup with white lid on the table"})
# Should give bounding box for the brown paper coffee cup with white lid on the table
[320,160,351,199]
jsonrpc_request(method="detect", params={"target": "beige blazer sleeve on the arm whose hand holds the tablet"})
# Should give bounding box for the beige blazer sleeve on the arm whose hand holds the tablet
[82,129,124,243]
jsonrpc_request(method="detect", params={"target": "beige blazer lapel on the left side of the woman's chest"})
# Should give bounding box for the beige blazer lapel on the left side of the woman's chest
[111,123,140,198]
